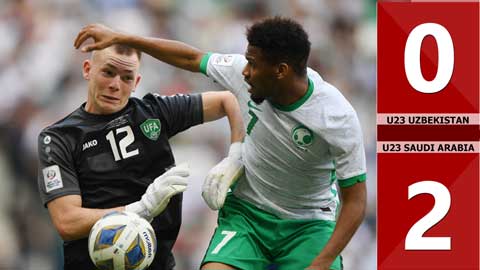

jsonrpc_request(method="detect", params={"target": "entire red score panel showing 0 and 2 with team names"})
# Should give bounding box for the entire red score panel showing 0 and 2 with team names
[377,0,480,270]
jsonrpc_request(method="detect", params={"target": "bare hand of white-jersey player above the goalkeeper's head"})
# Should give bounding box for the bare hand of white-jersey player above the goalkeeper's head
[73,23,121,52]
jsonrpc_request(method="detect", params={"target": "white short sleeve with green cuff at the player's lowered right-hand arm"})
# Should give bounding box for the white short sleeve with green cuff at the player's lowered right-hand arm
[325,111,366,187]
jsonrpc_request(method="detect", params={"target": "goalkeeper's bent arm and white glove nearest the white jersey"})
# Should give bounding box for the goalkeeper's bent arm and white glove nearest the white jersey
[202,91,245,210]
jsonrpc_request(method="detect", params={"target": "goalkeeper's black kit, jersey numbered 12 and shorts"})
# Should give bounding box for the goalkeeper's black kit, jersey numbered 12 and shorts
[38,94,203,270]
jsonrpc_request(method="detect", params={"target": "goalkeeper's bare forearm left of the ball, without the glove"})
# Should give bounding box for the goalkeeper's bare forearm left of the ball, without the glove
[56,207,124,241]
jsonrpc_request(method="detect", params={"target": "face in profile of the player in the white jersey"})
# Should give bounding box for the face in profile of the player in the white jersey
[242,45,276,104]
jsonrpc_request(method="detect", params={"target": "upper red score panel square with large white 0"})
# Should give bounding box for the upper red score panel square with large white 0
[377,1,479,113]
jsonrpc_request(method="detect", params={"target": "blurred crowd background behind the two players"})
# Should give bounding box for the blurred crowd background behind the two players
[0,0,376,270]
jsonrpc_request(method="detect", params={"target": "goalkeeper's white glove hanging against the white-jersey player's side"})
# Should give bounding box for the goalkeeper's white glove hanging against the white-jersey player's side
[202,142,244,210]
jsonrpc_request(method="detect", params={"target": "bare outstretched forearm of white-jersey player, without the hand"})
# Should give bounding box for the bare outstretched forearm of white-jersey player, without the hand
[117,34,203,72]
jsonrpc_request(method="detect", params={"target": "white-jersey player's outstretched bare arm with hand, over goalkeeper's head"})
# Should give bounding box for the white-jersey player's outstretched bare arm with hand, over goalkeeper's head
[74,24,204,72]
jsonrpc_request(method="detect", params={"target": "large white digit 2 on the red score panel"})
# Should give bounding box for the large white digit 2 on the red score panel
[405,181,451,250]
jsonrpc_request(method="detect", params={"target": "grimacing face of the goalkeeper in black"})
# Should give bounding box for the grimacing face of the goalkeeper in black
[83,48,140,114]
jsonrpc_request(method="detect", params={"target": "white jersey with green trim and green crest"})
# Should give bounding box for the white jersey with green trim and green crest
[201,54,366,220]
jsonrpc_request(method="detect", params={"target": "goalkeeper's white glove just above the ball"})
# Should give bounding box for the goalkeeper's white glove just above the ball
[125,163,190,222]
